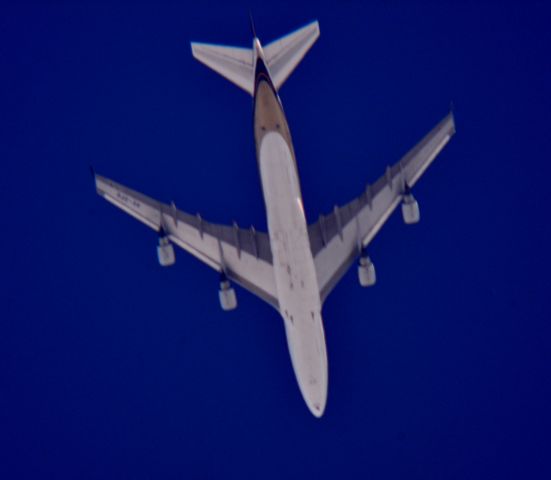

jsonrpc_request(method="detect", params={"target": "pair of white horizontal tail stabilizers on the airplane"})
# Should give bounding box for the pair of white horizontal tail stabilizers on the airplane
[191,21,319,95]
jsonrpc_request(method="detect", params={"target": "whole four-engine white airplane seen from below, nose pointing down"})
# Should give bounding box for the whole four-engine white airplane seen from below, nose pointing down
[93,21,455,418]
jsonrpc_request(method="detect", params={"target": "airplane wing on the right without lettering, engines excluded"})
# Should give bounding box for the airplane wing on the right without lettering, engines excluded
[308,112,455,302]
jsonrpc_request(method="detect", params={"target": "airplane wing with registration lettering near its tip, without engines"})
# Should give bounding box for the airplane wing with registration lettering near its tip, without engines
[94,174,278,308]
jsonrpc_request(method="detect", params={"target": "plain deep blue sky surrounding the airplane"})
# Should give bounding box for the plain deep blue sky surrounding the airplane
[0,1,551,479]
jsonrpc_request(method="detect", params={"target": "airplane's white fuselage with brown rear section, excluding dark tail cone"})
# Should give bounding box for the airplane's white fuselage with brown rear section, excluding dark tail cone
[254,62,327,417]
